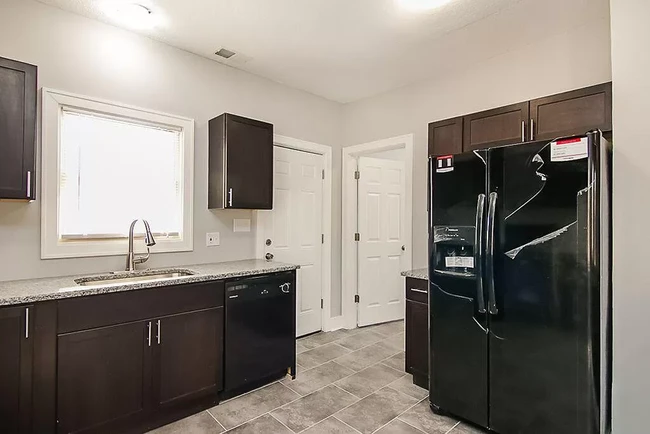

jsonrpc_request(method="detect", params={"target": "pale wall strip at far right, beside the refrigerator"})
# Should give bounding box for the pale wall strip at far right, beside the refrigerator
[611,0,650,434]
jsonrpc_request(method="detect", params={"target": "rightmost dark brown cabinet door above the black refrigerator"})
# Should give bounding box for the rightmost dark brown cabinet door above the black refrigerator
[530,83,612,140]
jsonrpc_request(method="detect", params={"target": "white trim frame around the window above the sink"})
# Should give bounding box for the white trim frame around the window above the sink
[41,88,194,259]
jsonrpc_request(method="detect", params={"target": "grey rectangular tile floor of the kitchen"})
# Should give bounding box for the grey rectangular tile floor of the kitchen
[151,321,482,434]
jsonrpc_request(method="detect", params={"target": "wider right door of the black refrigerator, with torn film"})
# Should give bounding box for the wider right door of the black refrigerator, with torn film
[486,137,599,434]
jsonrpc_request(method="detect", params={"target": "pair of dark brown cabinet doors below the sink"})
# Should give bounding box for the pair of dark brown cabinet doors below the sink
[57,307,224,433]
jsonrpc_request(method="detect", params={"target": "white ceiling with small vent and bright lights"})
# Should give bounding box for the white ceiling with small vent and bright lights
[39,0,609,103]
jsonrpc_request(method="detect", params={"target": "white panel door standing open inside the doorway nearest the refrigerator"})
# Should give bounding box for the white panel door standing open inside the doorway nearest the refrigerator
[357,157,406,326]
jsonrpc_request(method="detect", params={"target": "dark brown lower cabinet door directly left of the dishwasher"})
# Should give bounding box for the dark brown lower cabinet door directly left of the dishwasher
[154,307,224,406]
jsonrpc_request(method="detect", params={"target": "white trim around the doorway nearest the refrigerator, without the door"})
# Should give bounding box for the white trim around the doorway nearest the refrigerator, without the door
[341,134,413,329]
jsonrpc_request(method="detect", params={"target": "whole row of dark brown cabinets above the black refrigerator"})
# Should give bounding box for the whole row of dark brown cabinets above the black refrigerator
[429,83,612,156]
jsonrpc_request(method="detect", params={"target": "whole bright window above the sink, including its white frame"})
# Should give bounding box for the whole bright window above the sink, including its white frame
[41,89,194,259]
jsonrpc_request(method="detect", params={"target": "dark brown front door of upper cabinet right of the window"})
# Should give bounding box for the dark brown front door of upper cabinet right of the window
[225,114,273,209]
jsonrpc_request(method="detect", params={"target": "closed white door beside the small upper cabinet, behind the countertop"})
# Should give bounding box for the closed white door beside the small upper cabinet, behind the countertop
[258,146,323,336]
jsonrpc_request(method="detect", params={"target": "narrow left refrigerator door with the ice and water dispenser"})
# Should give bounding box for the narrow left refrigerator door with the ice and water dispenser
[429,152,488,426]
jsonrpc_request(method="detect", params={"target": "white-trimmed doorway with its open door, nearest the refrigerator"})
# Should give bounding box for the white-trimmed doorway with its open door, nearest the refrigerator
[341,134,413,328]
